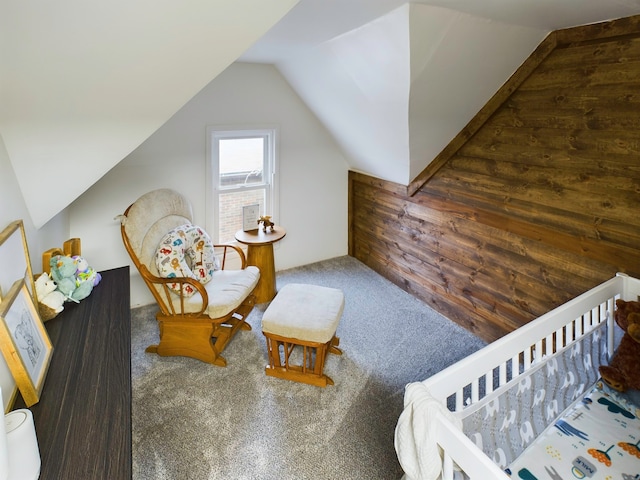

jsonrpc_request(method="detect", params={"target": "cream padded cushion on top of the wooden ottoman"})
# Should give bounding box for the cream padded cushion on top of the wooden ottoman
[262,283,344,343]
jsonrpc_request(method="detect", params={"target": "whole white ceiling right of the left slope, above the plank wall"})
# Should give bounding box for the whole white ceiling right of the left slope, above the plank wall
[241,0,640,184]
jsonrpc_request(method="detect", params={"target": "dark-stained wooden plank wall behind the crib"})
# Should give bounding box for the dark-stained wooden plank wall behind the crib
[349,17,640,341]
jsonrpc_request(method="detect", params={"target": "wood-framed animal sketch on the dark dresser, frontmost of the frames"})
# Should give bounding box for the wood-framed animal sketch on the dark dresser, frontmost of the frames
[0,279,53,407]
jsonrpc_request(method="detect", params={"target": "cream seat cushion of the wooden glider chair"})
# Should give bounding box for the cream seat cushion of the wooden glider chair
[172,266,260,318]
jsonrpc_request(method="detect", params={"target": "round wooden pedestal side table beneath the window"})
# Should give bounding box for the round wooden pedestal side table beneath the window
[236,226,287,303]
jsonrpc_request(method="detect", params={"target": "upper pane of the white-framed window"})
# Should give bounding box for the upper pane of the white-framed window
[218,137,264,187]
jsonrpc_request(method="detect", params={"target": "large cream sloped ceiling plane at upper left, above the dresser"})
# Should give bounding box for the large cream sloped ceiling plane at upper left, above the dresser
[0,0,297,227]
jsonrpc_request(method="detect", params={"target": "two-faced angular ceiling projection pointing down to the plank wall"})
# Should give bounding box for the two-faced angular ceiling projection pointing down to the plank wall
[278,4,547,185]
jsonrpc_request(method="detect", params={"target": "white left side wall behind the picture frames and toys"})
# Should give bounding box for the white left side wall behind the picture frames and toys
[0,137,69,410]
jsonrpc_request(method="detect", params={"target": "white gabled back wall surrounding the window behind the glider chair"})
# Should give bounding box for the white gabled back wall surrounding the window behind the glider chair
[69,63,348,306]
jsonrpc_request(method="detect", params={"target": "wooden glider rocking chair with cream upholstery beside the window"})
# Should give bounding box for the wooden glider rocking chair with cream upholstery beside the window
[120,189,260,367]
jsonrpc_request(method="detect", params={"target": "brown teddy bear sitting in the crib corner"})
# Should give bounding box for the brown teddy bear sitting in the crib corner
[599,300,640,392]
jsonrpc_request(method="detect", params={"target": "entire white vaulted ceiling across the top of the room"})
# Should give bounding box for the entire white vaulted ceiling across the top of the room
[0,0,640,226]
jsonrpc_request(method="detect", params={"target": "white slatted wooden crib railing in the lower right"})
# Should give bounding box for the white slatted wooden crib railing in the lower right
[404,274,640,480]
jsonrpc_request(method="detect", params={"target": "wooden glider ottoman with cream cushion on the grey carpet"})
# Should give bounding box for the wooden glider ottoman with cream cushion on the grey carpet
[262,283,344,387]
